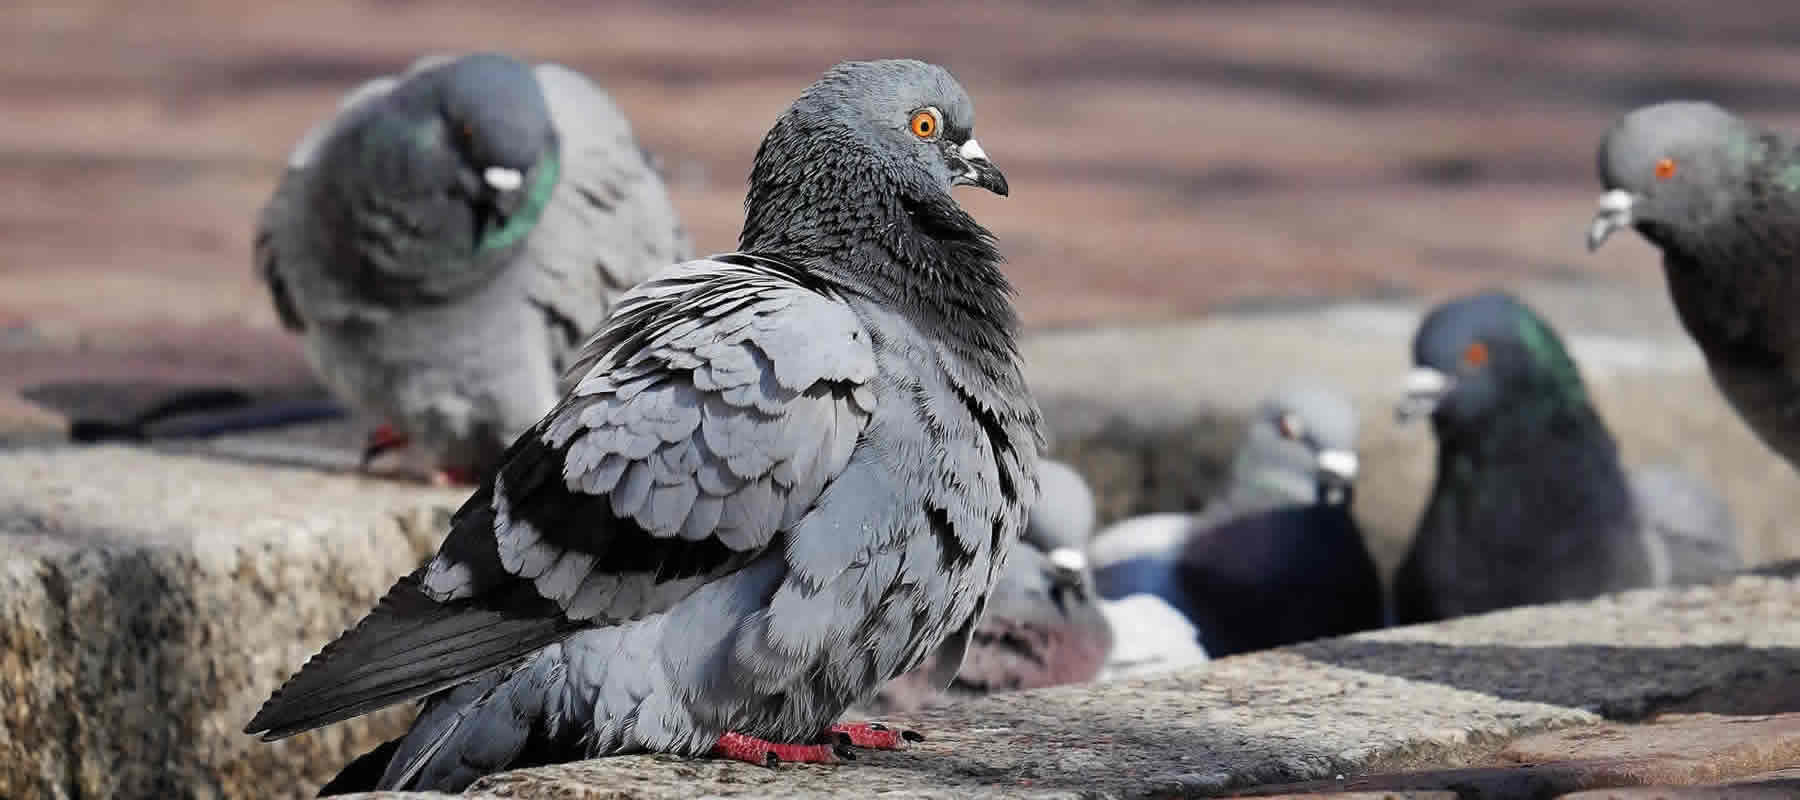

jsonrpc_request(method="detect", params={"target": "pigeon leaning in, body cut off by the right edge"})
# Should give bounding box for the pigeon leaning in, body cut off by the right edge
[1588,101,1800,467]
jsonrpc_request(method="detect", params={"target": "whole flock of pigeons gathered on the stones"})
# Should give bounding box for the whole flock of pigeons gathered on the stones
[200,52,1800,795]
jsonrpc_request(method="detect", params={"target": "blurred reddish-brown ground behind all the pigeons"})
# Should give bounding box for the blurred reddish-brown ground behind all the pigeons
[10,0,1800,557]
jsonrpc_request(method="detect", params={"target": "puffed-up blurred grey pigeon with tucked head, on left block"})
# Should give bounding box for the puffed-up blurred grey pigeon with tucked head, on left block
[256,54,689,483]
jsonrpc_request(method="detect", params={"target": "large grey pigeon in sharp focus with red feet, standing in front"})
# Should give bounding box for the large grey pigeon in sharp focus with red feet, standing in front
[247,59,1044,791]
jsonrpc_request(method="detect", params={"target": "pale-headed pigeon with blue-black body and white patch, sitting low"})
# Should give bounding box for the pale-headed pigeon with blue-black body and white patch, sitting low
[1094,380,1384,658]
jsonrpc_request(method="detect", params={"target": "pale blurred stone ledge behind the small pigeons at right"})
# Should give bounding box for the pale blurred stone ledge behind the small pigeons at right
[1024,283,1800,568]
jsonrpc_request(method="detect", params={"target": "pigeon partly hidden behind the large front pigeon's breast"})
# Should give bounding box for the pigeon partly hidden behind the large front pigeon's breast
[871,459,1112,712]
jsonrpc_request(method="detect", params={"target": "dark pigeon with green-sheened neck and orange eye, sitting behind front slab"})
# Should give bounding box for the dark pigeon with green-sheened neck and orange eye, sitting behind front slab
[1393,292,1739,623]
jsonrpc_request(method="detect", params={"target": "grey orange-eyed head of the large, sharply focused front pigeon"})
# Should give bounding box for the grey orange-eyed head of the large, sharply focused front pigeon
[740,59,1008,250]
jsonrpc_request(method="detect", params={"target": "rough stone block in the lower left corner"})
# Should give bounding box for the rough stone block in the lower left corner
[0,447,461,798]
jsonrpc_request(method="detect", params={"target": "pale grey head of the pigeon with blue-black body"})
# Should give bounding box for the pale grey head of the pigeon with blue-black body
[1231,380,1357,503]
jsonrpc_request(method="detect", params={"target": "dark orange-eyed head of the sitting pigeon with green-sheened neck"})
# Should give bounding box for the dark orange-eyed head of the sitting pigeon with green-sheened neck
[1397,292,1589,436]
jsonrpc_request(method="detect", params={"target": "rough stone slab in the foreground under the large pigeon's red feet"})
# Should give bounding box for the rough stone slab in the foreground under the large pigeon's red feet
[331,577,1800,800]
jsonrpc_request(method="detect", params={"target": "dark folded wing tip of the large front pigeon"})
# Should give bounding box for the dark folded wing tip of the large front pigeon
[243,571,578,741]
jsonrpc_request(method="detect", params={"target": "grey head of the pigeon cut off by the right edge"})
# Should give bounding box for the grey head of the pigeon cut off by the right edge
[1588,101,1755,250]
